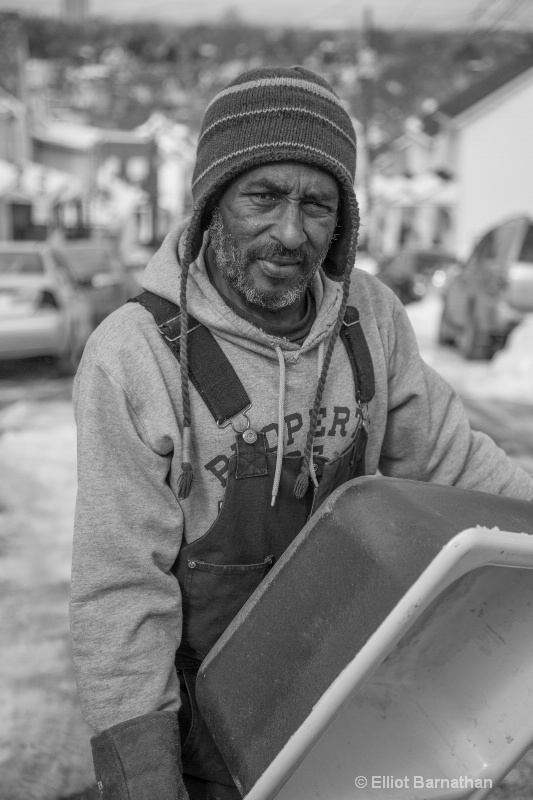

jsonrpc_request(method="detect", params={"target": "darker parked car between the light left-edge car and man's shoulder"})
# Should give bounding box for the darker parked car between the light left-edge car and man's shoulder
[54,240,138,328]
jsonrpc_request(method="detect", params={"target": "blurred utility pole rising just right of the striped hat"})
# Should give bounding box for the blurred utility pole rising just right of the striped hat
[357,6,376,250]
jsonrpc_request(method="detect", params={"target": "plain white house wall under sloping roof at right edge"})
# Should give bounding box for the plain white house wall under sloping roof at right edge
[456,71,533,256]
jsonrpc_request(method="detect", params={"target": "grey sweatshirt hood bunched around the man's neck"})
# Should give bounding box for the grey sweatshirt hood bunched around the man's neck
[142,221,342,366]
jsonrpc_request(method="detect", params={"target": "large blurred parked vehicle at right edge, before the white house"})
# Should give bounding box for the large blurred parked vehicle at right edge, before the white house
[438,217,533,358]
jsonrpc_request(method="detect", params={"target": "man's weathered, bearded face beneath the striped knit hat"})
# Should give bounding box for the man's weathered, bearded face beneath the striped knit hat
[209,161,339,311]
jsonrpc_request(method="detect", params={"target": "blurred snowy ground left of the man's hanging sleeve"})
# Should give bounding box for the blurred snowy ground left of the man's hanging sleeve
[0,400,94,800]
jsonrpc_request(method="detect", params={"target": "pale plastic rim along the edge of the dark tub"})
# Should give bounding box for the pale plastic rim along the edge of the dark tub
[244,527,533,800]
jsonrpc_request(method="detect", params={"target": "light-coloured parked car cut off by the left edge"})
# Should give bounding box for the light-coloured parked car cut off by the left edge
[0,241,92,373]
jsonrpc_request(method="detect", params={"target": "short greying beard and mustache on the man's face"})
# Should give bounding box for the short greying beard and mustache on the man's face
[208,208,329,311]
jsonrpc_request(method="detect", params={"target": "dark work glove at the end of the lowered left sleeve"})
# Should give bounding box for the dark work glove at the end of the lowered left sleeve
[91,711,189,800]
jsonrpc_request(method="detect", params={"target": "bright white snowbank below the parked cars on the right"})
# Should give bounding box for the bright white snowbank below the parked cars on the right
[406,292,533,405]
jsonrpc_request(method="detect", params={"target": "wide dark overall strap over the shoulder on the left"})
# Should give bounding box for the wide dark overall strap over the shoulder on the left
[128,291,251,427]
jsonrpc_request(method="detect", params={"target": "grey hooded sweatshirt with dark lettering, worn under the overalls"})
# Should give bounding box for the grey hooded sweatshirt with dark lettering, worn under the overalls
[71,222,533,731]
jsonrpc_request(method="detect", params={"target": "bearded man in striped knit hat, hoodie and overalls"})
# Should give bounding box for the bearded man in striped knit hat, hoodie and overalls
[71,67,533,800]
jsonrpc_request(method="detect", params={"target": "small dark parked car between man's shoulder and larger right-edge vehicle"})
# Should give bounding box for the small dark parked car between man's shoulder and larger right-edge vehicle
[377,247,455,305]
